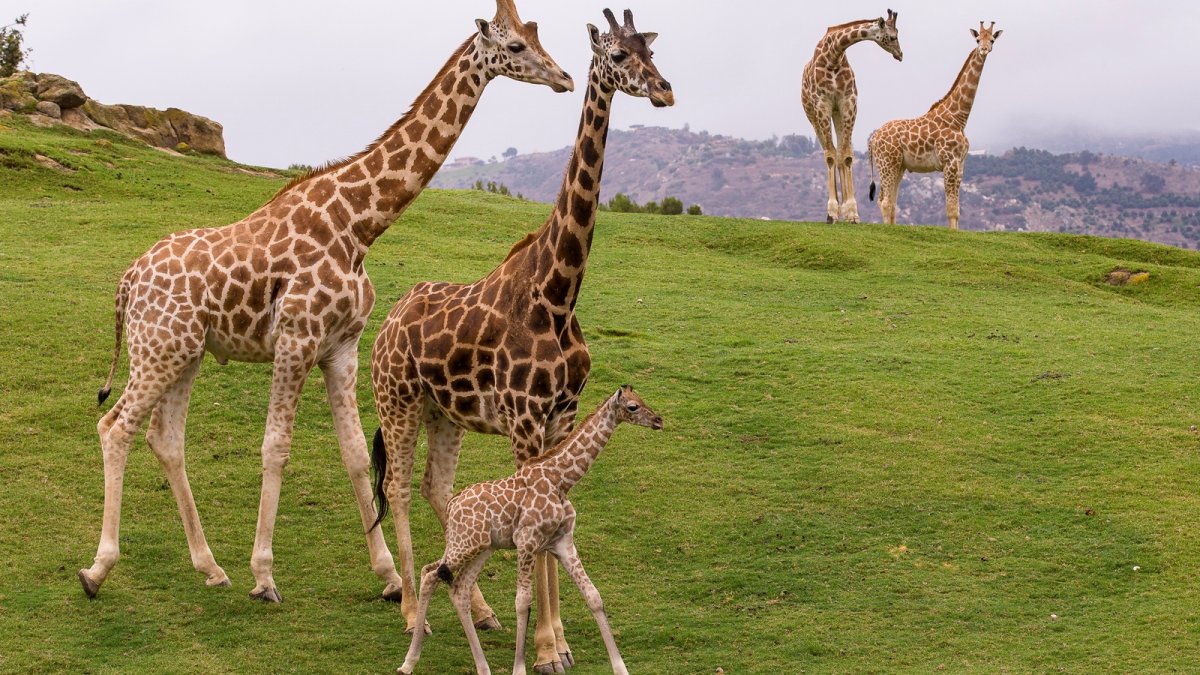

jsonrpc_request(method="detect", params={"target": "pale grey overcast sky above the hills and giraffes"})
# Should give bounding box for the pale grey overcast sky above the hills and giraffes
[16,0,1200,167]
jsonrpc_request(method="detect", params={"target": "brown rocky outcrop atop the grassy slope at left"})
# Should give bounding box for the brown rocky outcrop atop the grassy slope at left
[0,71,226,157]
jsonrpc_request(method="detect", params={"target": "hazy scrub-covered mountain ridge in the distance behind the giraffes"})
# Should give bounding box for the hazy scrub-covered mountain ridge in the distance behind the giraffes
[433,127,1200,249]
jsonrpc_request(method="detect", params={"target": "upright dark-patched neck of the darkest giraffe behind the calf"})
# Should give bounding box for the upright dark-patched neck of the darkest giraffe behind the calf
[509,60,616,315]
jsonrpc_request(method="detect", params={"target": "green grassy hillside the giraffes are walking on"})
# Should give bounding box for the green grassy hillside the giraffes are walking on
[7,119,1200,674]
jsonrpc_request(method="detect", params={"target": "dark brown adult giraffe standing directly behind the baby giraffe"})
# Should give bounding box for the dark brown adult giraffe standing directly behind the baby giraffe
[371,10,674,671]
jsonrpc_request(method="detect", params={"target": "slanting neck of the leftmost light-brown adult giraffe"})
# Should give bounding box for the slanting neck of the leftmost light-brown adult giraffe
[290,37,491,255]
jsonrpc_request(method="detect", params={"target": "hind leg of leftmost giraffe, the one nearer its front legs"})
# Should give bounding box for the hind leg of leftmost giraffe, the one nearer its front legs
[146,360,230,586]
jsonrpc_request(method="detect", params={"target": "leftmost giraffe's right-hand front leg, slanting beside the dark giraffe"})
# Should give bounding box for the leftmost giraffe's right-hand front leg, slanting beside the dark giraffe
[320,342,403,602]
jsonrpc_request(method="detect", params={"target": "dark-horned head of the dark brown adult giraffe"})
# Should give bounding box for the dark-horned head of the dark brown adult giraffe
[588,10,674,108]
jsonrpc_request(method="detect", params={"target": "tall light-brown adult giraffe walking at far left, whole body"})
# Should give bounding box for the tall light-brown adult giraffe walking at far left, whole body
[78,0,574,602]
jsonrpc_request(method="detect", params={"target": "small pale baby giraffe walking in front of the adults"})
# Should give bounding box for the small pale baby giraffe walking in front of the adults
[398,384,662,675]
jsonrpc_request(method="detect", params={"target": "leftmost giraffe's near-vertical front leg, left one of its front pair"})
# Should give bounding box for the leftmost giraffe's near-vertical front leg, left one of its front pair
[250,334,317,603]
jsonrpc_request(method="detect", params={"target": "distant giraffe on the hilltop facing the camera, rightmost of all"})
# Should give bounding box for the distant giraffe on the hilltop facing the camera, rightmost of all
[866,22,1004,229]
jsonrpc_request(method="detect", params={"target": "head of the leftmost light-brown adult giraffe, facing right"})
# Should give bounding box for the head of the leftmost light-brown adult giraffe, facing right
[475,0,575,92]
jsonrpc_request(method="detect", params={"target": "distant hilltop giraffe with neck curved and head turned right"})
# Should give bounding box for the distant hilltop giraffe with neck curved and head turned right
[800,10,904,222]
